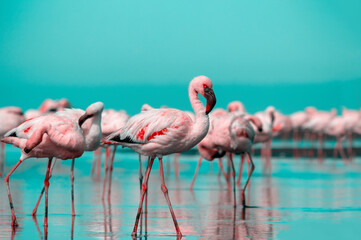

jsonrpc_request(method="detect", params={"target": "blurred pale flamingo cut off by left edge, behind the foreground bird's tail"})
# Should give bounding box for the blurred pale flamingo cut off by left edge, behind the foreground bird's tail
[0,107,25,177]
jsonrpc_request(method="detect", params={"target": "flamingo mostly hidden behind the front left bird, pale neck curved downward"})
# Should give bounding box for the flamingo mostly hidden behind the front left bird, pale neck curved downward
[32,102,104,216]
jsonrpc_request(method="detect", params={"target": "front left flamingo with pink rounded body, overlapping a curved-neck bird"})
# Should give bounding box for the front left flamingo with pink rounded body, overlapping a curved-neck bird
[1,109,85,226]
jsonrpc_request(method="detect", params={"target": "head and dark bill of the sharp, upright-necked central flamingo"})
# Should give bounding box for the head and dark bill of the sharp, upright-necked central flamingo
[190,76,217,115]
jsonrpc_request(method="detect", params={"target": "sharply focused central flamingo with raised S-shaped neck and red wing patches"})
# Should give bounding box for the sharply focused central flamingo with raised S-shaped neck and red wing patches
[107,76,216,237]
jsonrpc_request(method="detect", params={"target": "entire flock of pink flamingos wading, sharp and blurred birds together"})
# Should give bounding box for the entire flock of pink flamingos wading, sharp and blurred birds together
[0,76,361,237]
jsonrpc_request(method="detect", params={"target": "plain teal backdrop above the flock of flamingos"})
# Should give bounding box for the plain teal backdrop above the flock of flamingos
[0,0,361,114]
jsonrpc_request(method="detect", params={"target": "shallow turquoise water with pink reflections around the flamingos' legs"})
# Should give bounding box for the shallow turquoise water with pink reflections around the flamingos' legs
[0,148,361,239]
